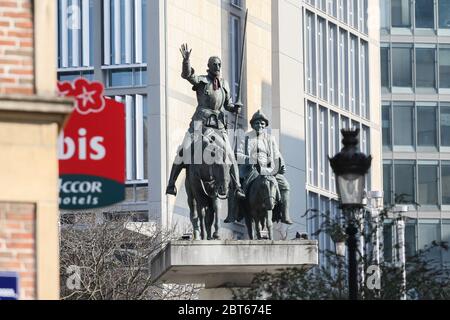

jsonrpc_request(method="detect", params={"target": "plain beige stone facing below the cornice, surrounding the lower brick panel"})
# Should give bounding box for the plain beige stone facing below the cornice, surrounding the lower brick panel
[0,111,59,299]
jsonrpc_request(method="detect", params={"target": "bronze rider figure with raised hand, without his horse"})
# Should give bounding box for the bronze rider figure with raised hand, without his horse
[166,44,245,198]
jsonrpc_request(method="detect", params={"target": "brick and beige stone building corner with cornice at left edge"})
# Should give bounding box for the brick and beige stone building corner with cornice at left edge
[0,0,72,299]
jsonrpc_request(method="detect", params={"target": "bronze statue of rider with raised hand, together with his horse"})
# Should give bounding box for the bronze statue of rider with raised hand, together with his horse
[166,44,245,239]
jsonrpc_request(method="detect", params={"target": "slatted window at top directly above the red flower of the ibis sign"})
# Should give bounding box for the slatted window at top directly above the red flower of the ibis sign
[58,0,94,68]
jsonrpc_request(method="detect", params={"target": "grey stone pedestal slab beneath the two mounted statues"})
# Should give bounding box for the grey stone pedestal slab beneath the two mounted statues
[151,240,318,300]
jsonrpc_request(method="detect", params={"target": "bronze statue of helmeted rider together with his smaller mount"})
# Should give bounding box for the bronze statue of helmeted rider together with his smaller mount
[226,111,293,239]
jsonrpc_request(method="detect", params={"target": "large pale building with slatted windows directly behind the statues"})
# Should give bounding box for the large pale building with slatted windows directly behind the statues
[58,0,382,245]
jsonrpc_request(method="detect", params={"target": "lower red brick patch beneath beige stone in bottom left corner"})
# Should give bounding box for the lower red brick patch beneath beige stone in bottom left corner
[0,202,36,300]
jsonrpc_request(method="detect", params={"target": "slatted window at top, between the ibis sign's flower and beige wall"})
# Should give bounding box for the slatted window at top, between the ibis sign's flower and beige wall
[103,0,147,65]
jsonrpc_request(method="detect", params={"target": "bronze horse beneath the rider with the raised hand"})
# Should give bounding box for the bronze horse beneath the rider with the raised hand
[185,128,230,240]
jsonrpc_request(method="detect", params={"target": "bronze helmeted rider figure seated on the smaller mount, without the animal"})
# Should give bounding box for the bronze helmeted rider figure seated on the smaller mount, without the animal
[227,111,293,224]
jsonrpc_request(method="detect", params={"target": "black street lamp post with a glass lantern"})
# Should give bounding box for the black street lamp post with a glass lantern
[329,129,372,300]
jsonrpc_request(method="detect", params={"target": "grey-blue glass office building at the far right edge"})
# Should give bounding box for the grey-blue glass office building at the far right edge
[380,0,450,263]
